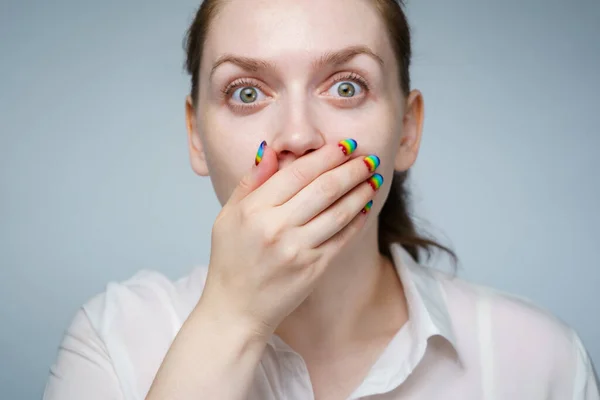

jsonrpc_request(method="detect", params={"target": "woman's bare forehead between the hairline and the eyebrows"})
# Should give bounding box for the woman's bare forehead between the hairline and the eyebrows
[204,0,392,62]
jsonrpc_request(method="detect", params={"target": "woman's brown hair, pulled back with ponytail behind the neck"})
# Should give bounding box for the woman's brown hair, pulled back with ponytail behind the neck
[184,0,457,265]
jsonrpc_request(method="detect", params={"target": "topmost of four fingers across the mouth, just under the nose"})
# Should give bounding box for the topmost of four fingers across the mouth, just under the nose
[253,139,357,206]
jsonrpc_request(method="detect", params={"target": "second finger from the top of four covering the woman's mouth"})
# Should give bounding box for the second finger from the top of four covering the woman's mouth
[280,155,383,226]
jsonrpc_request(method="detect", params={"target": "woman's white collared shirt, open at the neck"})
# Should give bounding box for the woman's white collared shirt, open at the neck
[44,244,600,400]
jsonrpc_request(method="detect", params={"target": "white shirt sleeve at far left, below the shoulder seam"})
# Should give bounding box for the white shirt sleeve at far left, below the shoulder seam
[43,308,124,400]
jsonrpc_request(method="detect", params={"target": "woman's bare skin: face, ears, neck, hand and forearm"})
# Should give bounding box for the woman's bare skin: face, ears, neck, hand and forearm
[148,0,423,399]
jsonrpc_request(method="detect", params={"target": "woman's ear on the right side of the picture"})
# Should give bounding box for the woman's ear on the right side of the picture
[394,90,425,172]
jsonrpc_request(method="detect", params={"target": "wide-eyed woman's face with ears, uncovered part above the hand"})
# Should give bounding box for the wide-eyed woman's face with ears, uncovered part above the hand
[188,0,422,204]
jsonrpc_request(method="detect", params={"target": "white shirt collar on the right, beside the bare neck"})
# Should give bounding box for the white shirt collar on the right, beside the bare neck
[351,243,463,398]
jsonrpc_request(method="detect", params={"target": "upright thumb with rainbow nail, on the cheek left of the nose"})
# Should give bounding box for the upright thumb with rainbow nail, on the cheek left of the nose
[228,140,279,203]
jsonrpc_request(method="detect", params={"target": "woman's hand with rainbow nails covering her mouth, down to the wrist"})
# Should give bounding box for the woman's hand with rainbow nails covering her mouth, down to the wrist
[199,140,383,339]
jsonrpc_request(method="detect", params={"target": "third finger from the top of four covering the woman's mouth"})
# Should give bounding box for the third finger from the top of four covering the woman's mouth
[295,175,381,248]
